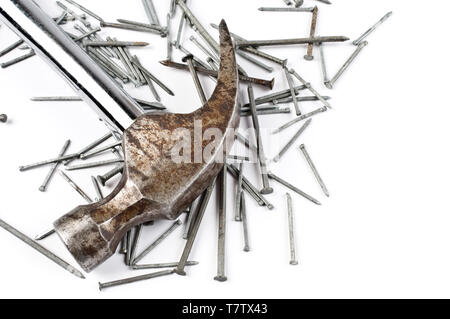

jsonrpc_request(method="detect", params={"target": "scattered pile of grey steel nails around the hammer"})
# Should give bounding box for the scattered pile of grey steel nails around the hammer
[0,0,392,289]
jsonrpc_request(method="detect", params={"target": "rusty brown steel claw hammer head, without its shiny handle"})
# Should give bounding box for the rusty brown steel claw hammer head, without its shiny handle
[54,21,240,272]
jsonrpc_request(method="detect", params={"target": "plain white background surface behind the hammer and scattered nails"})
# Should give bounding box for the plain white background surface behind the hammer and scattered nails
[0,0,450,298]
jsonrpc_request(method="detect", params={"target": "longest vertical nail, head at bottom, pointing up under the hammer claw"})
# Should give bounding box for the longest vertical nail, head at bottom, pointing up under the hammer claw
[214,165,227,282]
